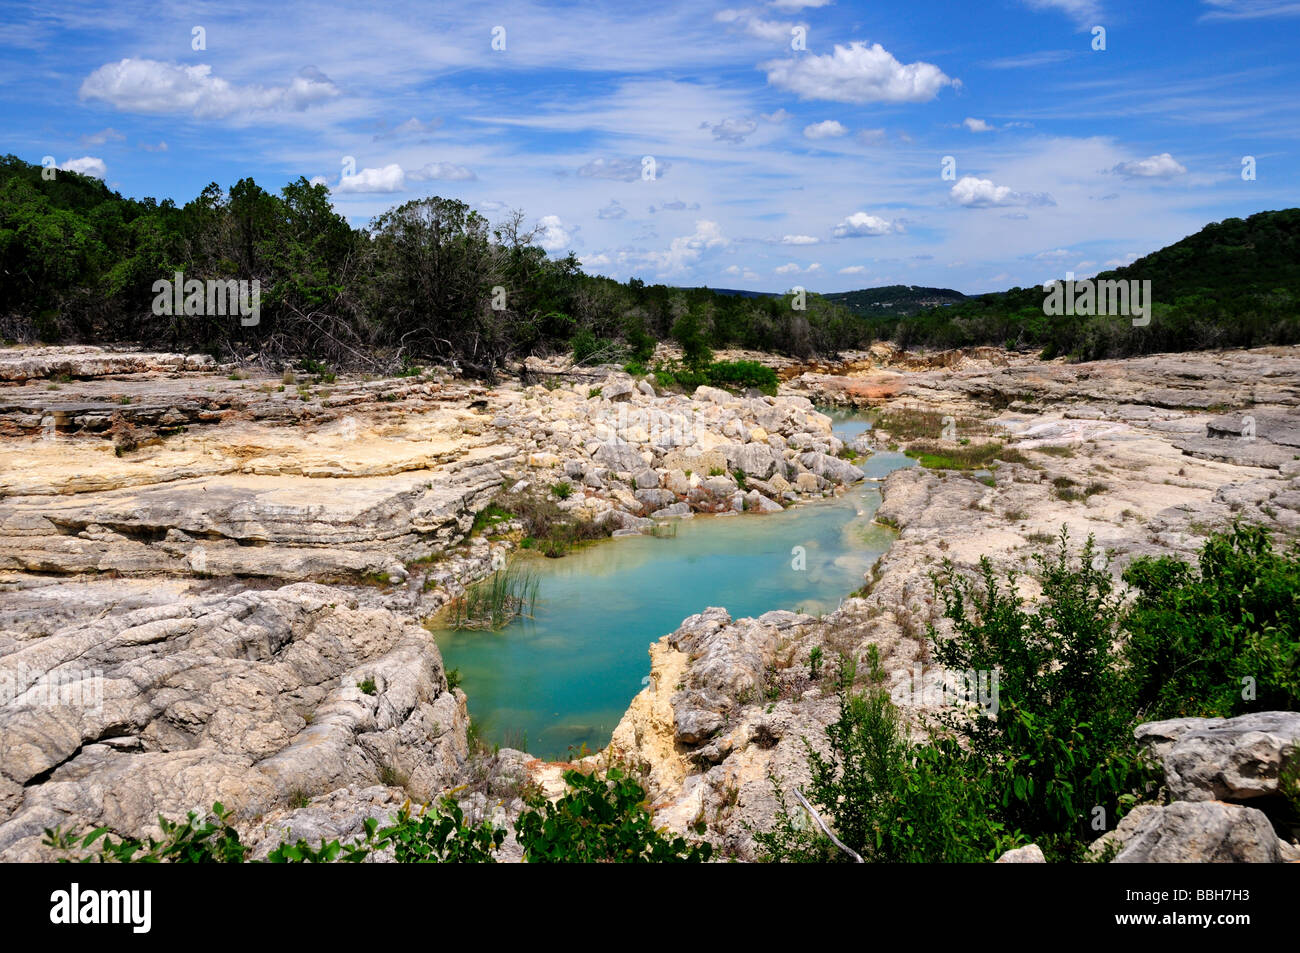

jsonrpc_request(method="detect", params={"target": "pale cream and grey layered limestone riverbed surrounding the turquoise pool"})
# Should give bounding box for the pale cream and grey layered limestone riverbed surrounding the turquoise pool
[0,347,1300,861]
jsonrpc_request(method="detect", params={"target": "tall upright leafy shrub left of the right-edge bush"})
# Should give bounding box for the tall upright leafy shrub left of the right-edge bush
[930,530,1145,857]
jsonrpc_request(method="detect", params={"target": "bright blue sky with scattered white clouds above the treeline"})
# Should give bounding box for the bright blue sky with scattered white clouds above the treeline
[0,0,1300,293]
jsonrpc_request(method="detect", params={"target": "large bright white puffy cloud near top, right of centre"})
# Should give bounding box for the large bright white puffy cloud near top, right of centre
[759,43,959,104]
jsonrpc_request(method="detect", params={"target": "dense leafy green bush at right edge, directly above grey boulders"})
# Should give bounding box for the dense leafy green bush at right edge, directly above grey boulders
[1125,525,1300,719]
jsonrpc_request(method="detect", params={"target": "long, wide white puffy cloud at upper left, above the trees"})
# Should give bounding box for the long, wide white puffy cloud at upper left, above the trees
[79,57,341,118]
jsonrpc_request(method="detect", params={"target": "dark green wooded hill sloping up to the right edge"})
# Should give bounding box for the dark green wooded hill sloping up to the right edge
[894,208,1300,360]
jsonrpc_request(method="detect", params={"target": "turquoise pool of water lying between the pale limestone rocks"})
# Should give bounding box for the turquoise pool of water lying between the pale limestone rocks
[438,420,913,757]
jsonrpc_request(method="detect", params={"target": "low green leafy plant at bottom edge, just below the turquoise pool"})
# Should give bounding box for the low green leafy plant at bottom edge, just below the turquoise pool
[515,766,712,863]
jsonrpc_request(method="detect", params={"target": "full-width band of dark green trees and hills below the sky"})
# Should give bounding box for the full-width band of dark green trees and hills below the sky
[0,156,1300,366]
